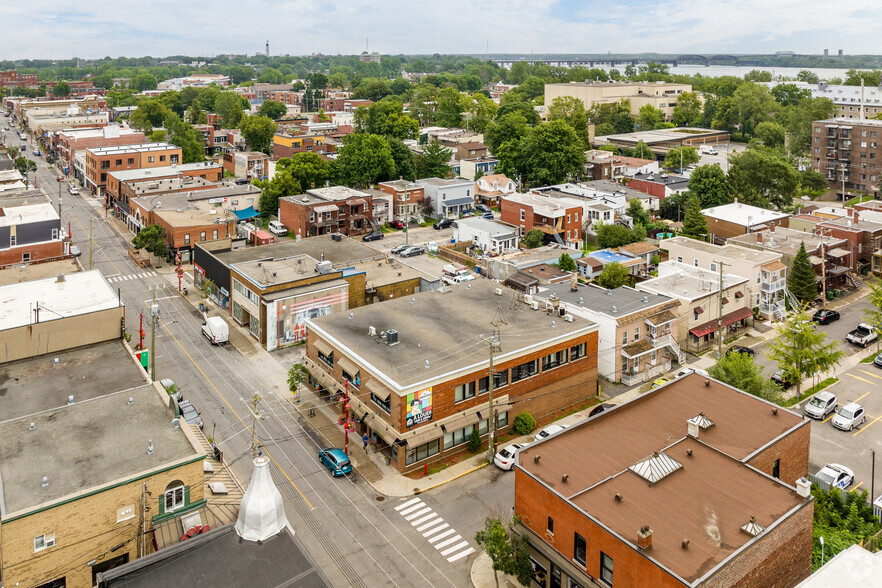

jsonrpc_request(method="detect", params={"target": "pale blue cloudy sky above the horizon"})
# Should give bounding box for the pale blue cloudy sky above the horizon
[6,0,882,59]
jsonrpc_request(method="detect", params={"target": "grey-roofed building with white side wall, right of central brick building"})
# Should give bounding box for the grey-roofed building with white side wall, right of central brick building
[534,284,686,386]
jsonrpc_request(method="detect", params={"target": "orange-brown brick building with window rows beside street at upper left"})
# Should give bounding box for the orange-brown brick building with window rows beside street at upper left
[85,143,182,200]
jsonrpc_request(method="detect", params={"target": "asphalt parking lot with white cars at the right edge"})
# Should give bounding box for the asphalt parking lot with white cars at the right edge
[808,363,882,498]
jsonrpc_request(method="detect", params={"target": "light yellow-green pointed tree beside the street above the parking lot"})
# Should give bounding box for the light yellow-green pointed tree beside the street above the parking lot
[768,307,843,400]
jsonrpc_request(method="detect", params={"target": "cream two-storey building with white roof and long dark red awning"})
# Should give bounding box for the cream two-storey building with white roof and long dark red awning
[637,261,753,353]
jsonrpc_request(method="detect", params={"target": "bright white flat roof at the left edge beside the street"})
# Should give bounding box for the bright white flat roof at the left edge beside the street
[0,270,120,330]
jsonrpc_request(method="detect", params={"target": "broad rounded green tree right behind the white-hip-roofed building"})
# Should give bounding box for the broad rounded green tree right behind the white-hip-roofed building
[729,149,801,208]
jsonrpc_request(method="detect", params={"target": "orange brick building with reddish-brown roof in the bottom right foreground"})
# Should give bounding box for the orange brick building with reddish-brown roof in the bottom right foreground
[514,374,814,588]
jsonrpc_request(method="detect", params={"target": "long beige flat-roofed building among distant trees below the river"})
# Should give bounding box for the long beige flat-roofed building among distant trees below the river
[543,82,692,120]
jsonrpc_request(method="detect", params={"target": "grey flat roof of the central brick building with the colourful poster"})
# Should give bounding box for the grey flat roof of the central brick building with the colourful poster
[307,280,597,392]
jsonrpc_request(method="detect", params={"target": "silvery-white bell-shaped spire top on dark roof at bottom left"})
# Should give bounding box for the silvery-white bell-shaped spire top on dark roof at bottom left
[236,456,288,541]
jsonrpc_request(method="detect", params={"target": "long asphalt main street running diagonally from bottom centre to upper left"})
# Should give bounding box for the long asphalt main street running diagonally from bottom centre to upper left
[16,125,484,587]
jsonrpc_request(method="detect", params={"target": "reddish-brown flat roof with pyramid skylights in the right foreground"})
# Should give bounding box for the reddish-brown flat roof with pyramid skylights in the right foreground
[518,374,808,582]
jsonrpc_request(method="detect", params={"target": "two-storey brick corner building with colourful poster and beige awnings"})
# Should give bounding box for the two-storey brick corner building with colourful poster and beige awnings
[305,280,597,471]
